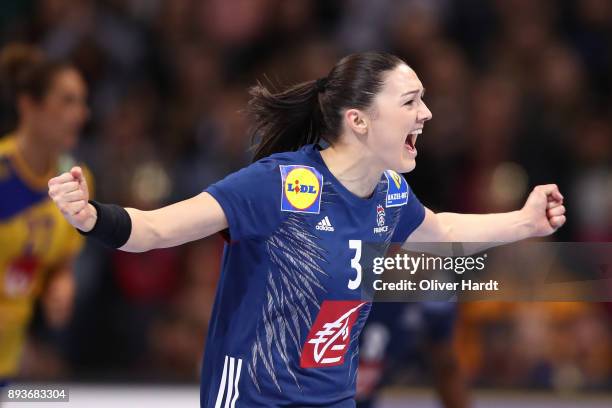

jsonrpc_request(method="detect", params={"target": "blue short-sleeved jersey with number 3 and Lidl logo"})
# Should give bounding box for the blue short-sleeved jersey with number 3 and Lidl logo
[200,145,425,408]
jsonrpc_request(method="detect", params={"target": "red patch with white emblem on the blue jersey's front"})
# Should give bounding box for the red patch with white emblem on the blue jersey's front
[300,300,366,368]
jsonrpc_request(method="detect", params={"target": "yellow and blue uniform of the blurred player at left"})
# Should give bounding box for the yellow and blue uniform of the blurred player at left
[0,135,91,379]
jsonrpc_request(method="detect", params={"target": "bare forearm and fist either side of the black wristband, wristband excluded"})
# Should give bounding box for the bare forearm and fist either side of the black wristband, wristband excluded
[49,167,228,252]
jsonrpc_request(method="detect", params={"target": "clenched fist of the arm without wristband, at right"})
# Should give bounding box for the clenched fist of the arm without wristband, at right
[521,184,565,237]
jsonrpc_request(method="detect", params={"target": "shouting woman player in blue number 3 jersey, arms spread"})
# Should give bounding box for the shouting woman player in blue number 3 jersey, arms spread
[48,53,565,408]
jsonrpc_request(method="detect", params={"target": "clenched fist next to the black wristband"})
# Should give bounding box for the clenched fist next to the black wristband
[49,167,97,232]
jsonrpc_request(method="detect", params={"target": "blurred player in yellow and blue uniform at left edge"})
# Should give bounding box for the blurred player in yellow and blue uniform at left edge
[0,44,91,382]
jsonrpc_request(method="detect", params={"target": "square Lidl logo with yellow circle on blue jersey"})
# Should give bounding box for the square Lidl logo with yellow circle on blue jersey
[279,165,323,214]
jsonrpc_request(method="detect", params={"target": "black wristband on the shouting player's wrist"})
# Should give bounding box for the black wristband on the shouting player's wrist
[77,200,132,248]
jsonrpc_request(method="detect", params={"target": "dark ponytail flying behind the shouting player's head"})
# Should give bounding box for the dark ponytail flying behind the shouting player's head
[247,80,325,161]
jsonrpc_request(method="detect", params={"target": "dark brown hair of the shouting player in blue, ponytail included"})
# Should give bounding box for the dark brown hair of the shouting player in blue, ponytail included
[247,52,404,161]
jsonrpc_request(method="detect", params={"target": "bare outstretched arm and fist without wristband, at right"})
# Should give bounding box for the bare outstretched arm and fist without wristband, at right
[406,184,565,255]
